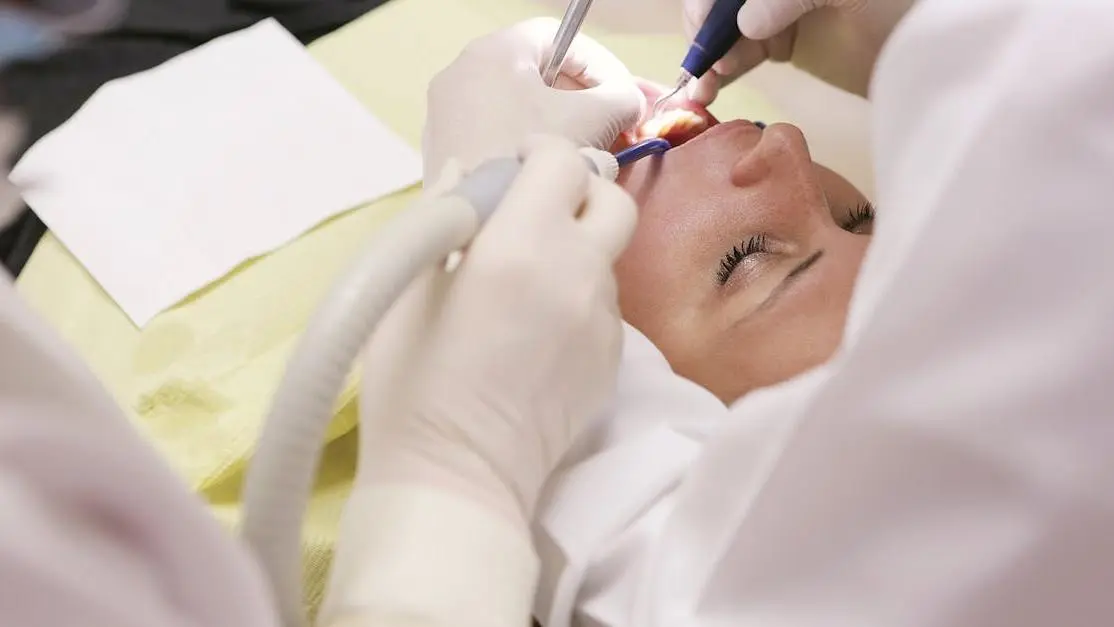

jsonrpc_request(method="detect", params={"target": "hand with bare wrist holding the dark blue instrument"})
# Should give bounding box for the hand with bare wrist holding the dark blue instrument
[683,0,916,105]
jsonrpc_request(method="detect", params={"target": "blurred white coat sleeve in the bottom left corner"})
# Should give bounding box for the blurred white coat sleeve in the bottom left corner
[0,277,277,627]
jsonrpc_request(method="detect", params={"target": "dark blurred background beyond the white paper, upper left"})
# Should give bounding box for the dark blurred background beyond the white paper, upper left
[0,0,388,275]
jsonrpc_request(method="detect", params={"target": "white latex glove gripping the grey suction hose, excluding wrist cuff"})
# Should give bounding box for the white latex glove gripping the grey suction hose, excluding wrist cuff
[356,137,636,533]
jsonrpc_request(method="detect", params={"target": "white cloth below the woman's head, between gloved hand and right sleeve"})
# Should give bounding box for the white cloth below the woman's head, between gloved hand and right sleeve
[535,323,727,626]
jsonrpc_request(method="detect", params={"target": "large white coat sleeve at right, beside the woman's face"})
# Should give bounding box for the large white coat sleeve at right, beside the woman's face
[633,0,1114,627]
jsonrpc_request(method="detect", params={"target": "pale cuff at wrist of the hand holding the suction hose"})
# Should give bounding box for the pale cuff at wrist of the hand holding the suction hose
[319,484,539,627]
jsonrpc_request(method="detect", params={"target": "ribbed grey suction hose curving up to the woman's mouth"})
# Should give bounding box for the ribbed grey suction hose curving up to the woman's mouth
[241,149,618,627]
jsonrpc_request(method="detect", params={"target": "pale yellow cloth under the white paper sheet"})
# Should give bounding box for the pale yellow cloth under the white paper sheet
[19,0,774,619]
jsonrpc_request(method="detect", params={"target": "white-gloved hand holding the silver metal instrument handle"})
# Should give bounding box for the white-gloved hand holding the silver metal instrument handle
[422,18,646,180]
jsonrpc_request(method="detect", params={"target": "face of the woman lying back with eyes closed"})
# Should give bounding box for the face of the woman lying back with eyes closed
[616,100,873,402]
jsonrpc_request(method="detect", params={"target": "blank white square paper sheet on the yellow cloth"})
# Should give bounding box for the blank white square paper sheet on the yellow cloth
[11,20,421,327]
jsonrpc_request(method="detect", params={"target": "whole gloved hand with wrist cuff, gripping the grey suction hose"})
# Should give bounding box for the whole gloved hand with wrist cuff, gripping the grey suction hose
[321,137,636,627]
